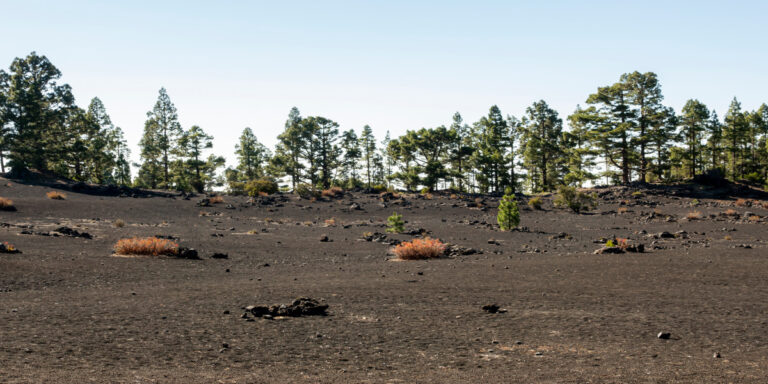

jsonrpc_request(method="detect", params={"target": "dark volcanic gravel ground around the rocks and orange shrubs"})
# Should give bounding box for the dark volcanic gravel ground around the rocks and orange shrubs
[0,179,768,383]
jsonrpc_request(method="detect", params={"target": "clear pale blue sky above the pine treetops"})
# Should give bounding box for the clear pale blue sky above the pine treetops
[0,0,768,164]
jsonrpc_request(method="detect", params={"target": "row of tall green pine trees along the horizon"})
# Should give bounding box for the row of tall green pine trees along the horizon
[0,52,768,193]
